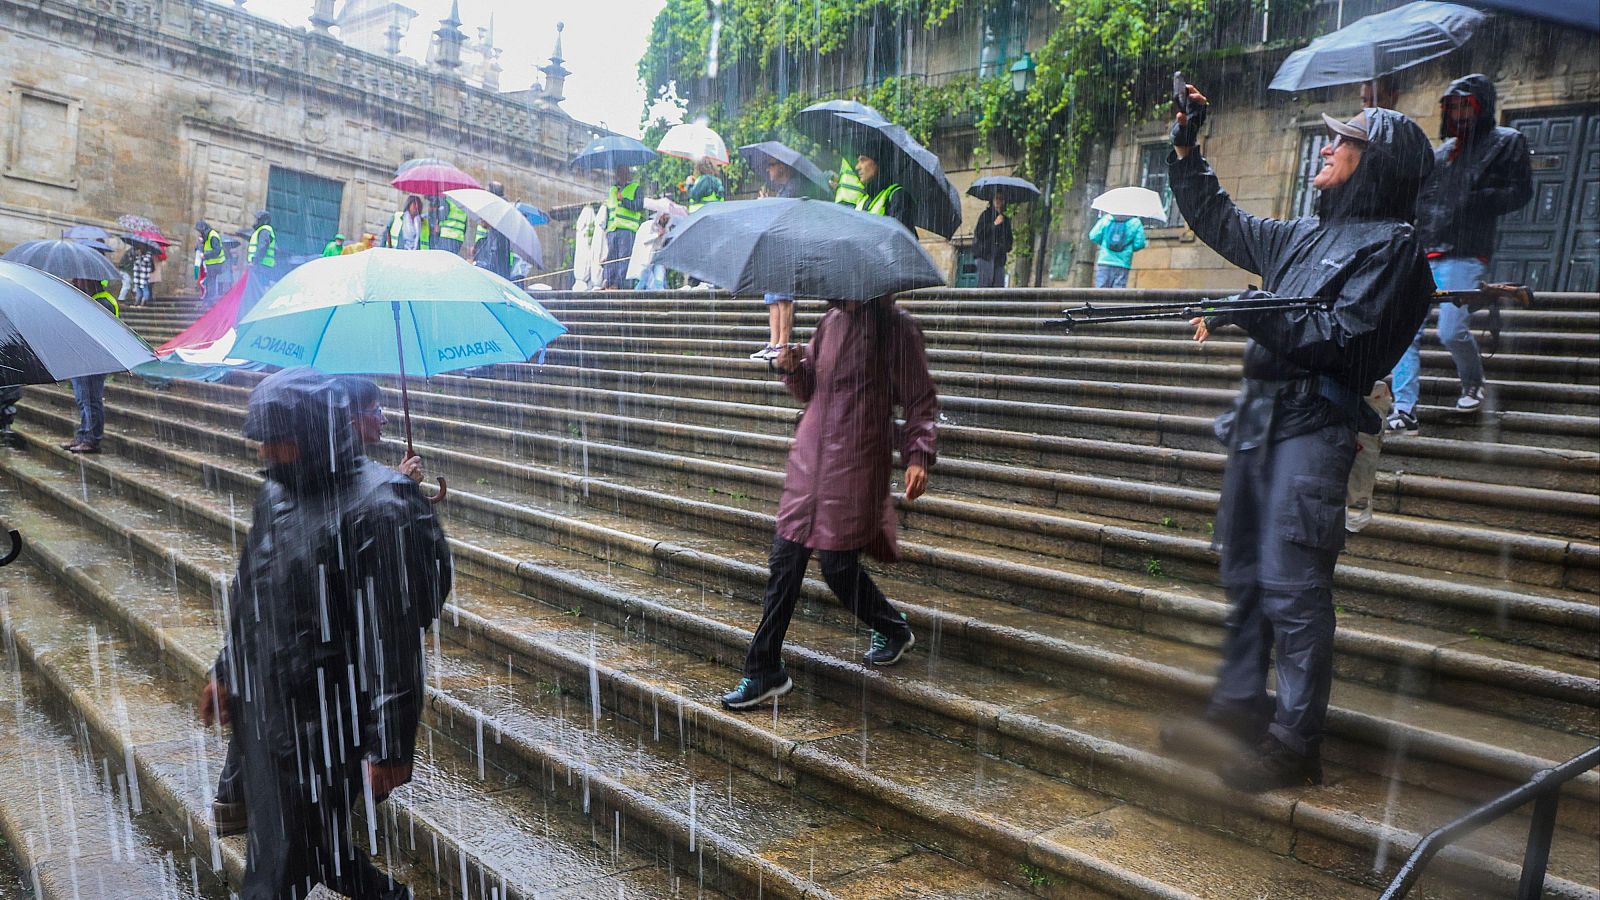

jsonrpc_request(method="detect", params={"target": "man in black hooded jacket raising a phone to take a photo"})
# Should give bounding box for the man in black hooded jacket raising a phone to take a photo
[1162,86,1434,791]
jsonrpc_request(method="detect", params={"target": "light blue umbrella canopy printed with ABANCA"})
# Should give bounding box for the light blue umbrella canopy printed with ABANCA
[230,247,566,376]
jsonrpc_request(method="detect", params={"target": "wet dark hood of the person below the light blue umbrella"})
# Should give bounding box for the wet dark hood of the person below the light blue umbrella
[245,368,360,493]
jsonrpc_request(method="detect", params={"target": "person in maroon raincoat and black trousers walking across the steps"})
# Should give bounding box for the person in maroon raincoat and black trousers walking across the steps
[722,298,939,709]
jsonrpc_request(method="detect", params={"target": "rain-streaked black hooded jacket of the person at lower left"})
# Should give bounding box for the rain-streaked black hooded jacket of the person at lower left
[214,368,451,768]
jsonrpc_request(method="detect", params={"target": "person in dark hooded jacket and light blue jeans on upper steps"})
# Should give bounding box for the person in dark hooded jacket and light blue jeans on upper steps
[1389,75,1533,434]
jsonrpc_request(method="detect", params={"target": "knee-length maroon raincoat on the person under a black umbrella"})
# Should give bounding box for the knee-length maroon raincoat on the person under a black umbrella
[778,299,939,560]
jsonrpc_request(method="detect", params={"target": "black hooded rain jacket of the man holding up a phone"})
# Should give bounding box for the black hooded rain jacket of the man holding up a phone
[1168,109,1434,448]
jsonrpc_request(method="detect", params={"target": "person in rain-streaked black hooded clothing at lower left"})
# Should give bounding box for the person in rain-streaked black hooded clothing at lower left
[200,368,451,900]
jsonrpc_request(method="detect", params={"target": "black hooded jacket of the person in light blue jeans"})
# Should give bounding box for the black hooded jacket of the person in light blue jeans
[1416,75,1533,259]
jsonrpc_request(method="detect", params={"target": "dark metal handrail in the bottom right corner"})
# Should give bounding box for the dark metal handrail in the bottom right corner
[1379,745,1600,900]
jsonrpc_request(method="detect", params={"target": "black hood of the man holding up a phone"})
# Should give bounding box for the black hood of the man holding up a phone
[1317,109,1434,223]
